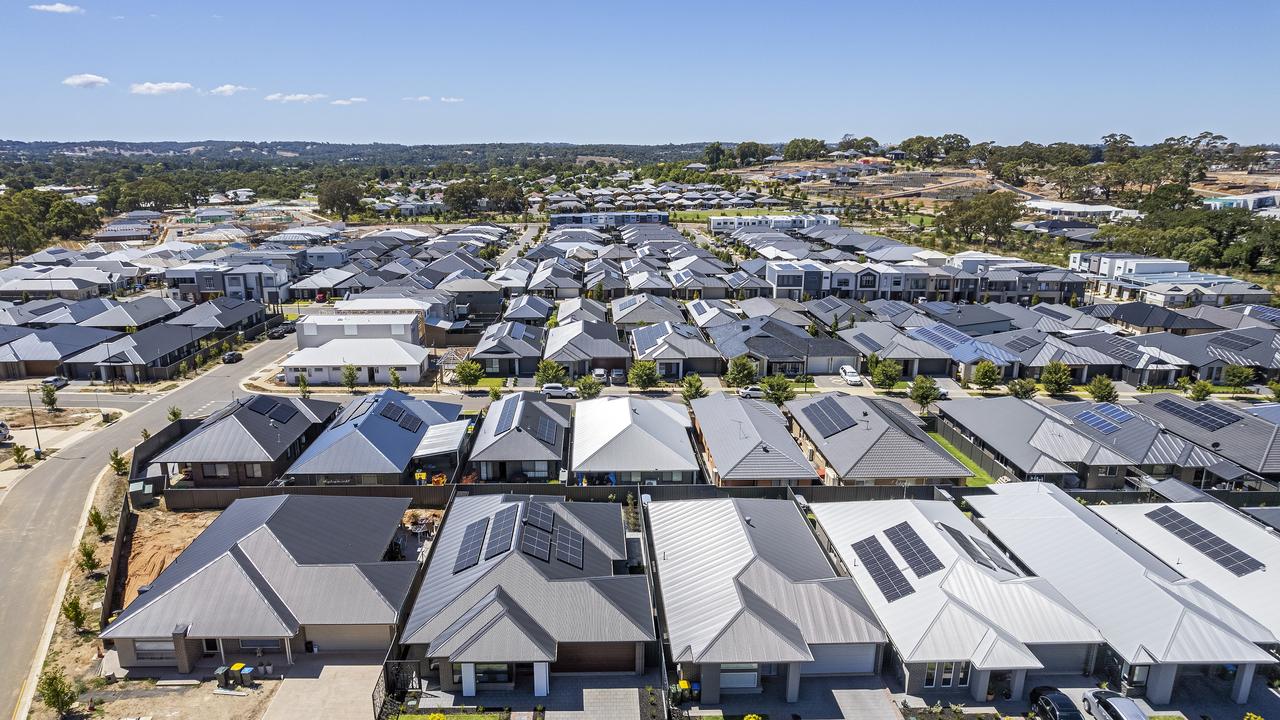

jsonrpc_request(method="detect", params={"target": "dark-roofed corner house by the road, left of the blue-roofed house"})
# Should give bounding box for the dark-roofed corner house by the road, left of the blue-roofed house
[151,395,342,488]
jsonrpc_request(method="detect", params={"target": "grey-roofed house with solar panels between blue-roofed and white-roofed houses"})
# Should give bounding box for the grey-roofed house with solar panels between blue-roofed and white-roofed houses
[471,391,570,483]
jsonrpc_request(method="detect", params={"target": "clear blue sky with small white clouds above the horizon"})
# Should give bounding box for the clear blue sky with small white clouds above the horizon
[0,0,1280,143]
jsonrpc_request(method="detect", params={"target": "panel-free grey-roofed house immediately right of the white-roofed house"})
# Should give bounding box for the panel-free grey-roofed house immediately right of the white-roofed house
[690,392,818,486]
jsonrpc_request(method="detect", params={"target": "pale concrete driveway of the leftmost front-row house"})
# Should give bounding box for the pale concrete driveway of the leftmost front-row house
[262,652,383,720]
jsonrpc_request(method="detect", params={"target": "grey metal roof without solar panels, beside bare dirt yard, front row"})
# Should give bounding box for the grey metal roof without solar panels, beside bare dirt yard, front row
[101,495,417,639]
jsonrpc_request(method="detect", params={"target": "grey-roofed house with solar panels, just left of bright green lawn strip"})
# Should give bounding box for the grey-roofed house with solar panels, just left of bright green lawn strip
[783,392,973,486]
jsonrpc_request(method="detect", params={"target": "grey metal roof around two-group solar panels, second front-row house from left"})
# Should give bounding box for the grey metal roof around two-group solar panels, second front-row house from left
[402,495,657,662]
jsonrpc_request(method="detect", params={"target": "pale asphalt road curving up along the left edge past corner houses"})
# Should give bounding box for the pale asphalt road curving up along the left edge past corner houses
[0,338,293,717]
